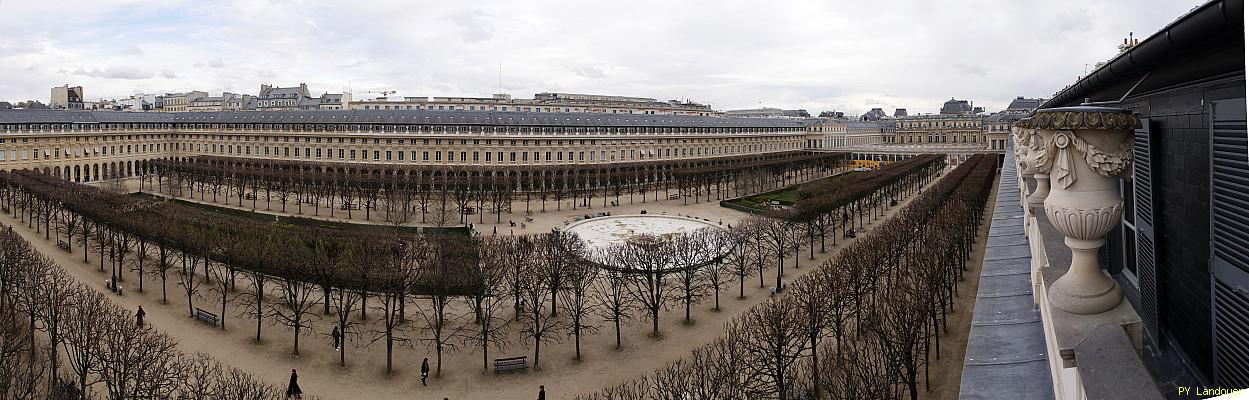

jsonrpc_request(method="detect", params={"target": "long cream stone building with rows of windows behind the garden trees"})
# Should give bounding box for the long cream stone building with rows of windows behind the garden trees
[0,110,807,181]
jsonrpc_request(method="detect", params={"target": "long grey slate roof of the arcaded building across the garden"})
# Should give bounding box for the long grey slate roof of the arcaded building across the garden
[0,110,806,128]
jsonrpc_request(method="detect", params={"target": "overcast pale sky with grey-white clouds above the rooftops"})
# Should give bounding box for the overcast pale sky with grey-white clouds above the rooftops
[0,0,1203,114]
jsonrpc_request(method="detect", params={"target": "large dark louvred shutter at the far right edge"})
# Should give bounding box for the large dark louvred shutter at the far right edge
[1210,99,1249,388]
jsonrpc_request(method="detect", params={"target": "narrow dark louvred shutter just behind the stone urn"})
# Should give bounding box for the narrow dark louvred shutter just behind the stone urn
[1132,118,1163,346]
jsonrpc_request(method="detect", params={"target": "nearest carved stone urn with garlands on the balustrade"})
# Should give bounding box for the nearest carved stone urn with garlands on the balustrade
[1033,106,1140,314]
